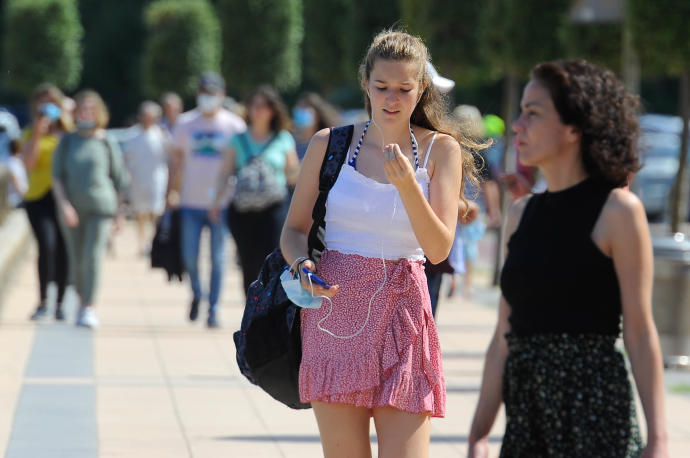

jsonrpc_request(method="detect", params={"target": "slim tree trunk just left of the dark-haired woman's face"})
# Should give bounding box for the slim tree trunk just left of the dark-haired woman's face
[493,70,520,285]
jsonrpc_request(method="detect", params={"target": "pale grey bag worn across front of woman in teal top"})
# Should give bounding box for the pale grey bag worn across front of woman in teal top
[232,132,287,212]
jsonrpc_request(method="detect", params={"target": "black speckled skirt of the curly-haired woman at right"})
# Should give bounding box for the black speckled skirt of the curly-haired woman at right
[500,334,642,458]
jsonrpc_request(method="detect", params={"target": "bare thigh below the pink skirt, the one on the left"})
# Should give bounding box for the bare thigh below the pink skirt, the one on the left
[311,402,371,458]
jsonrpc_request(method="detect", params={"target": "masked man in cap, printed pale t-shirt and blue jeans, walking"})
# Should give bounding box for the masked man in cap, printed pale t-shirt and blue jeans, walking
[168,72,247,328]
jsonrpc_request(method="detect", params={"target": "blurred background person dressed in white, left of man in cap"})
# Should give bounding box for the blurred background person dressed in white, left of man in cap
[123,100,171,255]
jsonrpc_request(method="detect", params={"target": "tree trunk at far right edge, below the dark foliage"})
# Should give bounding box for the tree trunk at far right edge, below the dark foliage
[671,68,690,233]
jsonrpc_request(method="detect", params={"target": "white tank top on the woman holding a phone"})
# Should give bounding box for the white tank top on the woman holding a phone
[325,132,436,261]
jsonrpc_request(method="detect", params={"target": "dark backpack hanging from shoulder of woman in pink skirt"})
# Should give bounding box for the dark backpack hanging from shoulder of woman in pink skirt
[233,126,354,409]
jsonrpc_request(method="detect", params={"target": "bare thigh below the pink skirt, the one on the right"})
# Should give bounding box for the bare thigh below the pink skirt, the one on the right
[374,407,430,458]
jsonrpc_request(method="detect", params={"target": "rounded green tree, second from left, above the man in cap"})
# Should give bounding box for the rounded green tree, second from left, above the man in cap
[142,0,221,97]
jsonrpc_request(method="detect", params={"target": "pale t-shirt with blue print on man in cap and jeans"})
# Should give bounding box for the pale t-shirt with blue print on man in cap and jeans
[173,109,247,209]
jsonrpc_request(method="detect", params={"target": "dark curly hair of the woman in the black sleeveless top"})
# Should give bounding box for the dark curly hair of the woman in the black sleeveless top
[532,60,640,187]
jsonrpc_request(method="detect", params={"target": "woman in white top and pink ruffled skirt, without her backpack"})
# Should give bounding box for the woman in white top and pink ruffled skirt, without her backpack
[281,31,476,458]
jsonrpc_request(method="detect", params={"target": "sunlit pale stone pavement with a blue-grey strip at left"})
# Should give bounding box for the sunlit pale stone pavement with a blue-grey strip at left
[0,227,690,458]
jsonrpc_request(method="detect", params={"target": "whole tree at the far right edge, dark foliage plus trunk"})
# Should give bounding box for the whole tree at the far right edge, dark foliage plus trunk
[628,0,690,232]
